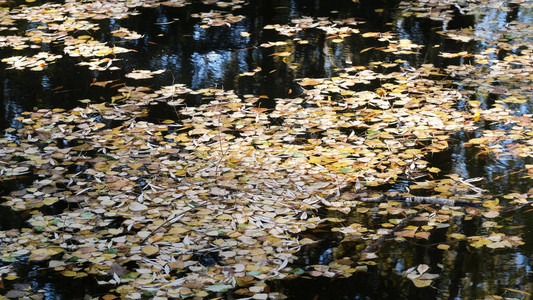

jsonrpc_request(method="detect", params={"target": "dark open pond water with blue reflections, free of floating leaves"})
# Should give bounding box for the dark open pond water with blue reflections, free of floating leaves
[0,0,533,299]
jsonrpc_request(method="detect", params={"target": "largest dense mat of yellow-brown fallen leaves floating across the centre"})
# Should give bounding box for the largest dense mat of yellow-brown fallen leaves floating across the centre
[1,60,520,297]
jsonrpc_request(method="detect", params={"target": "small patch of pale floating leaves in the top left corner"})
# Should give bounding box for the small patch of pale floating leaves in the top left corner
[0,0,189,71]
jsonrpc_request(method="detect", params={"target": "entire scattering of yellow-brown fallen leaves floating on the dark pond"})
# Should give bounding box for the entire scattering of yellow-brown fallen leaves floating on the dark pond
[0,1,533,299]
